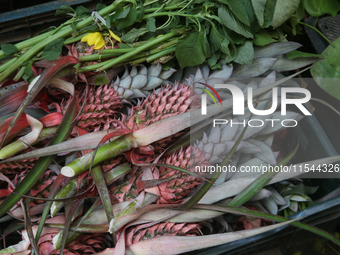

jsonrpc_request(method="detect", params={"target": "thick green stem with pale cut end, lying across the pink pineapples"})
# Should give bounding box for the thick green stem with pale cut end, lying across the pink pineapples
[61,134,133,177]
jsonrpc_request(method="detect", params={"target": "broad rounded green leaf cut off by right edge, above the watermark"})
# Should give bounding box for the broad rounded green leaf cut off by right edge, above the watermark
[311,38,340,100]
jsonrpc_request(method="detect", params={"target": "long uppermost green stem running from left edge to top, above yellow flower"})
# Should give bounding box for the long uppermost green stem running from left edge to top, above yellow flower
[0,0,125,82]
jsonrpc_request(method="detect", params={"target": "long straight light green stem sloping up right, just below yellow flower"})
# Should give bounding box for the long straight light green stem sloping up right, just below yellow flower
[99,32,176,71]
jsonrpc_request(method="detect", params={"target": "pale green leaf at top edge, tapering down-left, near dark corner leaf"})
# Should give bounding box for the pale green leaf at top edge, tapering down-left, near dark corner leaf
[270,0,300,28]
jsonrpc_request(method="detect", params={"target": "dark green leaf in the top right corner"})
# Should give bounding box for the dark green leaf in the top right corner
[304,0,340,17]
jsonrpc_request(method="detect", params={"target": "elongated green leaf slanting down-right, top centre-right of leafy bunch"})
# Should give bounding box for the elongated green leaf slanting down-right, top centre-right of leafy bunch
[218,6,253,38]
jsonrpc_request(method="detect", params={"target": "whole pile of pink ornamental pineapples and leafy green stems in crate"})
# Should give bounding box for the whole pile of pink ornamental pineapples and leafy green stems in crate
[0,0,340,255]
